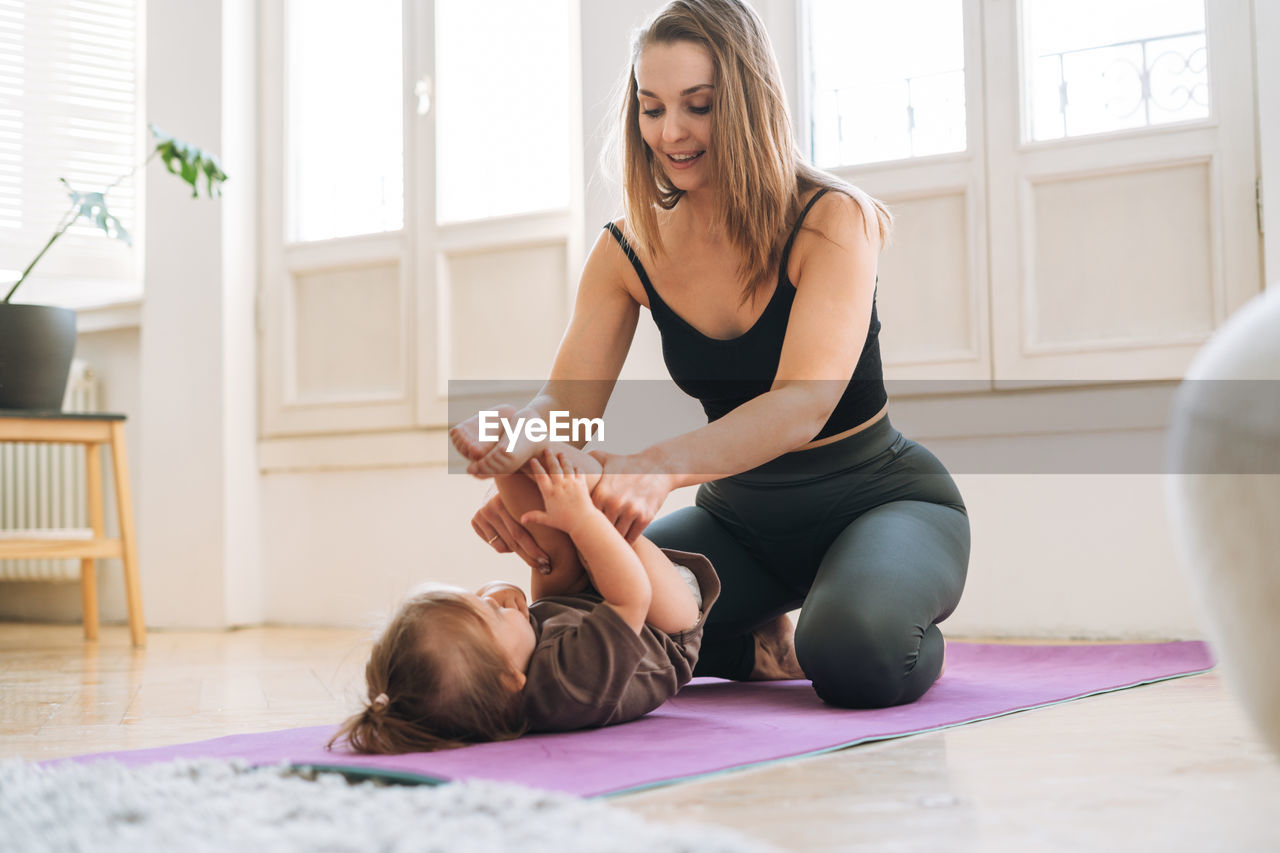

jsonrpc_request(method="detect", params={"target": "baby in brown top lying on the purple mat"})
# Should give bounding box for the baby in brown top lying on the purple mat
[329,446,719,753]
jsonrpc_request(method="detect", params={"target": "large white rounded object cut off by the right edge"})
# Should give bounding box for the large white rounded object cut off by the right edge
[1166,287,1280,753]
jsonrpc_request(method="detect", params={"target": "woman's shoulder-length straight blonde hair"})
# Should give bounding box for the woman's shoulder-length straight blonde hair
[620,0,892,302]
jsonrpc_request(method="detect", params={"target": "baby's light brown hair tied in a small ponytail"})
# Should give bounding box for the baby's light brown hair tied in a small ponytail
[328,590,527,754]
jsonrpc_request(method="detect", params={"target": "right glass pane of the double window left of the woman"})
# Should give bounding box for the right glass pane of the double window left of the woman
[435,0,571,222]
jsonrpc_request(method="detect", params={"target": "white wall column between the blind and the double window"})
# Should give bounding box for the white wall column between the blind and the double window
[138,0,264,628]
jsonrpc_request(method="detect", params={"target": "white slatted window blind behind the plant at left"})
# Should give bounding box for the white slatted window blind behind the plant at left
[0,0,141,301]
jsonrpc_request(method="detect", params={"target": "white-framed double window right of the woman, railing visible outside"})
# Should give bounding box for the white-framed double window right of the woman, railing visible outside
[800,0,1260,386]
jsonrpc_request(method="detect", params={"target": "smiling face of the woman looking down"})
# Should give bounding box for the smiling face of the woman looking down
[635,41,716,192]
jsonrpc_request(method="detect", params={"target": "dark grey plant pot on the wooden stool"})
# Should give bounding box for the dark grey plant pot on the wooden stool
[0,302,76,411]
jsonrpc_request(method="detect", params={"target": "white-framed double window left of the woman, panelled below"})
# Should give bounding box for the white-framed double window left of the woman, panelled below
[259,0,582,438]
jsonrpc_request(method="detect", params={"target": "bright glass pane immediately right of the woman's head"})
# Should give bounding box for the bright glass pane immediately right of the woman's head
[809,0,965,167]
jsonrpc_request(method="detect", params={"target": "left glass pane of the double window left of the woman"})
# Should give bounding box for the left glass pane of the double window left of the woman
[285,0,404,242]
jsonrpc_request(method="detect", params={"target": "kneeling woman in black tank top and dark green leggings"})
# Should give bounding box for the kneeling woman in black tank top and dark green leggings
[453,0,969,707]
